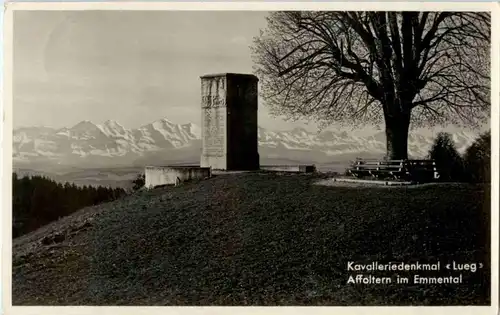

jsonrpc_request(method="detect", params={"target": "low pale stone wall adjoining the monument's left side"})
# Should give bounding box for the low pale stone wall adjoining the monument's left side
[144,165,212,188]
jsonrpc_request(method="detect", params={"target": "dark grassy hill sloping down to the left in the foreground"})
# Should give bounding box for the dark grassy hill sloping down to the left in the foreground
[12,173,490,305]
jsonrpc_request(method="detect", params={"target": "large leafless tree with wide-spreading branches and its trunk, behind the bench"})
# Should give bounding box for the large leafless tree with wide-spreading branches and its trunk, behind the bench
[252,11,491,159]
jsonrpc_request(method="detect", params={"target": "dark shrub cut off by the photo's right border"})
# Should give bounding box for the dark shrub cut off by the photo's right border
[464,132,491,183]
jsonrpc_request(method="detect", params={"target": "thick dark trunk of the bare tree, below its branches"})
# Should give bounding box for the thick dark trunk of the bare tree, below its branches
[385,115,410,160]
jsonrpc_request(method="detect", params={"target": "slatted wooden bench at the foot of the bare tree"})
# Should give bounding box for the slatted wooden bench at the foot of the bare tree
[347,158,437,182]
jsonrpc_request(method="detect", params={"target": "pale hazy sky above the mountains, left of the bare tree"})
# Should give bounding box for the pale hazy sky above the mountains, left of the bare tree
[13,11,324,129]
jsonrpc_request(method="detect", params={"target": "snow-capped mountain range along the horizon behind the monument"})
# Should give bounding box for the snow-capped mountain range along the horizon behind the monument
[13,119,477,167]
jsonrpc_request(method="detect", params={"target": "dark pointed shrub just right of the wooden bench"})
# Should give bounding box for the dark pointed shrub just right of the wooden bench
[429,132,464,181]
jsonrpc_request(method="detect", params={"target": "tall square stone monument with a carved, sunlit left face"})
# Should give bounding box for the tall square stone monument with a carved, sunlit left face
[200,73,259,170]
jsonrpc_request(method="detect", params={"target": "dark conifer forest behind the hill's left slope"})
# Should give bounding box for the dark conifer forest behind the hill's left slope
[12,173,126,237]
